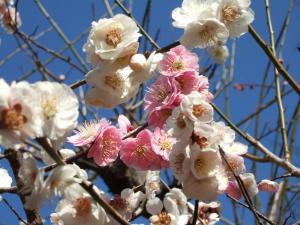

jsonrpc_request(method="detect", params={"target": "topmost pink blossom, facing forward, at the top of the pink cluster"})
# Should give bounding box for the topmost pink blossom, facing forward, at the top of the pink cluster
[160,45,199,76]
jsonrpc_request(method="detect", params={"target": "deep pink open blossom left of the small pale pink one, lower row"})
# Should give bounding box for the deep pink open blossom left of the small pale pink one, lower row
[120,129,167,170]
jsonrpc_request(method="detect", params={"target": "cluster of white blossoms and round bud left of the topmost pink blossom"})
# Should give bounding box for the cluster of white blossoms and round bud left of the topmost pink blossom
[83,14,162,108]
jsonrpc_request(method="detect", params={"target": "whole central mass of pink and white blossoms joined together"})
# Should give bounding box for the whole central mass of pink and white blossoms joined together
[69,46,278,202]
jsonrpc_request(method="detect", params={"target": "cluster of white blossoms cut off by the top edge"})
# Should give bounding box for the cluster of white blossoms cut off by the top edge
[172,0,254,63]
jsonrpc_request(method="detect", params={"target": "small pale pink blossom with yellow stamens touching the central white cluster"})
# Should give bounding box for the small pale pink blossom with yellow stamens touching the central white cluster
[152,127,177,161]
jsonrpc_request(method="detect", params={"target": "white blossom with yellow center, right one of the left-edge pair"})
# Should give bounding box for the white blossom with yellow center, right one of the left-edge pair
[33,81,79,140]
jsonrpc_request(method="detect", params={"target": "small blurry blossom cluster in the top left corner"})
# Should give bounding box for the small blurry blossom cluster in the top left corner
[0,0,22,34]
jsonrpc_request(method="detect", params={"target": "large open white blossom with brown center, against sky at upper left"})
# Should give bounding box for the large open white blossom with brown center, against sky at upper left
[83,14,141,65]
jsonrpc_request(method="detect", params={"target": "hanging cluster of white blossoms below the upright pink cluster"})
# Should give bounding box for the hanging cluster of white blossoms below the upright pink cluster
[166,92,247,202]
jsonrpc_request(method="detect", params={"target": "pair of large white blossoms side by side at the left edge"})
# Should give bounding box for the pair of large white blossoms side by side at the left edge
[0,79,79,148]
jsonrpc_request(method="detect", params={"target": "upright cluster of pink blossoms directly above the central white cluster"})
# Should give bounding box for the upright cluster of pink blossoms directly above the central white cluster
[145,45,212,128]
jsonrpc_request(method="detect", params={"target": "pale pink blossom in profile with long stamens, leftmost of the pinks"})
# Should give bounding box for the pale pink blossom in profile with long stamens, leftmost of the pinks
[68,119,109,146]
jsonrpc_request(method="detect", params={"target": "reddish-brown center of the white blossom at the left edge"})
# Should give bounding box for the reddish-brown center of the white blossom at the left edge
[0,104,27,130]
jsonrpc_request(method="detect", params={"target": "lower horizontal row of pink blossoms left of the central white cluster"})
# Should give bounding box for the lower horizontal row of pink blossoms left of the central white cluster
[68,115,176,170]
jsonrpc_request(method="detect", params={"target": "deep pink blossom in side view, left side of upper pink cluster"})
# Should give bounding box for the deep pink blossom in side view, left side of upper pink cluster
[145,76,180,111]
